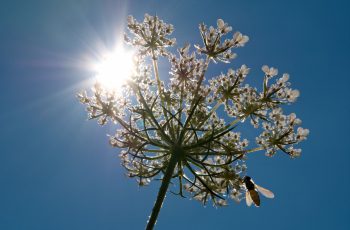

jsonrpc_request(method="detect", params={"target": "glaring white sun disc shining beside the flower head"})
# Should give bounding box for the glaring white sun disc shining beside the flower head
[95,46,135,91]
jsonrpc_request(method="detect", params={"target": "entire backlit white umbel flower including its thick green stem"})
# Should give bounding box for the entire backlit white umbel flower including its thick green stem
[78,14,309,229]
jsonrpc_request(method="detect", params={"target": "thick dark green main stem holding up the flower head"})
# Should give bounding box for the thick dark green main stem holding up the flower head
[146,152,178,230]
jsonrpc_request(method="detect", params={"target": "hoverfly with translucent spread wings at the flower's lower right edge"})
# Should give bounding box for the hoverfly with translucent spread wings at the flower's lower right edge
[243,176,275,207]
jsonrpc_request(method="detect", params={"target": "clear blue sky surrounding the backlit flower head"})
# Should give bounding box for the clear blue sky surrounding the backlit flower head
[0,0,350,230]
